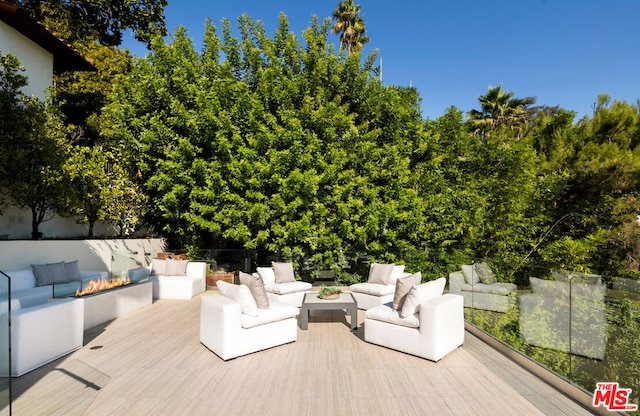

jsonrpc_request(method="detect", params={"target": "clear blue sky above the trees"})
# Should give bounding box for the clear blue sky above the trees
[122,0,640,119]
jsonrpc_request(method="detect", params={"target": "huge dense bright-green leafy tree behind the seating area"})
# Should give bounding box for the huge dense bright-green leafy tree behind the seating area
[103,15,446,269]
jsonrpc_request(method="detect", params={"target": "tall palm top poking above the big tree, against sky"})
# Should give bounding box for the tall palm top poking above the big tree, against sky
[331,0,369,54]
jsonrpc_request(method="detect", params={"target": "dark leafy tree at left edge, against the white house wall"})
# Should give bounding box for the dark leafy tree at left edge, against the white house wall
[0,53,69,238]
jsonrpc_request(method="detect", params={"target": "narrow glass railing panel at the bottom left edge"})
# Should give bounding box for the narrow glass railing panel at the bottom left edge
[0,272,11,416]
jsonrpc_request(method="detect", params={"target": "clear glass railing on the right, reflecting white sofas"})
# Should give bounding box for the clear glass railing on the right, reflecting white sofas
[458,263,640,412]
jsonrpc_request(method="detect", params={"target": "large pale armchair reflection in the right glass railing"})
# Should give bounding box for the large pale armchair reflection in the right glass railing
[519,276,607,360]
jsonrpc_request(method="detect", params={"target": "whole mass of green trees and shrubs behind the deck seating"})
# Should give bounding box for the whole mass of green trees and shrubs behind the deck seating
[101,15,640,283]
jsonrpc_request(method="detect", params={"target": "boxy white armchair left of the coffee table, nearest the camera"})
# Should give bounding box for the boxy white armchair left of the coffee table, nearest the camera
[200,290,299,360]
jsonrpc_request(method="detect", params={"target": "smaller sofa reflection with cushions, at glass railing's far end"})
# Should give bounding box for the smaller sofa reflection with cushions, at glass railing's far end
[449,263,517,312]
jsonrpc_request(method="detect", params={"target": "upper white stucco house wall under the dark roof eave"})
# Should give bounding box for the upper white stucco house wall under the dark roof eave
[0,21,53,101]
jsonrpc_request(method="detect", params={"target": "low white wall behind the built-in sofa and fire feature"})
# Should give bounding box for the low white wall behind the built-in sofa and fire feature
[0,238,166,272]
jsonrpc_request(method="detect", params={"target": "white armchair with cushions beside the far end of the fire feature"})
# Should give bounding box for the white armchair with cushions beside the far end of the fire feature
[149,259,207,299]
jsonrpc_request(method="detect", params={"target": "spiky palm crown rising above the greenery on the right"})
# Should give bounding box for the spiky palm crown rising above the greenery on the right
[468,85,536,139]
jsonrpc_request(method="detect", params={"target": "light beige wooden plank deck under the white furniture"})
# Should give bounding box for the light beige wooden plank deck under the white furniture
[7,290,592,416]
